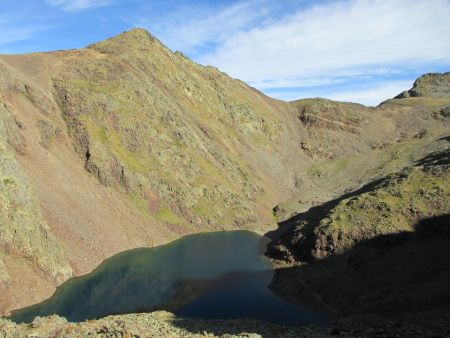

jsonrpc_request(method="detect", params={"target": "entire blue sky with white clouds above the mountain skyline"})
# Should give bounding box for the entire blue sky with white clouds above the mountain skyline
[0,0,450,105]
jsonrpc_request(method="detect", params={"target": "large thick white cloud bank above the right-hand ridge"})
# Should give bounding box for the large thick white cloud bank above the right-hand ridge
[202,0,450,81]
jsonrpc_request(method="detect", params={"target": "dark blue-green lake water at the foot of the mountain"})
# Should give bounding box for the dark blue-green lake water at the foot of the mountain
[11,231,326,325]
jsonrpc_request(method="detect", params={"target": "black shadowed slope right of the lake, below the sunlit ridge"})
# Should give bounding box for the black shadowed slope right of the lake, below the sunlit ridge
[271,214,450,337]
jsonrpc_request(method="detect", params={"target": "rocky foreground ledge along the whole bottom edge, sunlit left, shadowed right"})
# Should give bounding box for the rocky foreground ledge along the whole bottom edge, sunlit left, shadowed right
[4,311,449,338]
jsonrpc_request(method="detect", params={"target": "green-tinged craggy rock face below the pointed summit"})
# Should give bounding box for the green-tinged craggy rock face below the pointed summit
[54,30,281,227]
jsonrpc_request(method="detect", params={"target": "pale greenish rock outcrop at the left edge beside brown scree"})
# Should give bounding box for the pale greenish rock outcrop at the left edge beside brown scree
[0,104,72,283]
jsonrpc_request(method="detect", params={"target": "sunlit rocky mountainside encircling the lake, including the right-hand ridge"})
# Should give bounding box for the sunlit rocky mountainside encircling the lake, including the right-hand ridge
[0,29,450,332]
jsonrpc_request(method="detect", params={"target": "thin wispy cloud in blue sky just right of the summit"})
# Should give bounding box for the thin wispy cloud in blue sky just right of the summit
[129,0,299,55]
